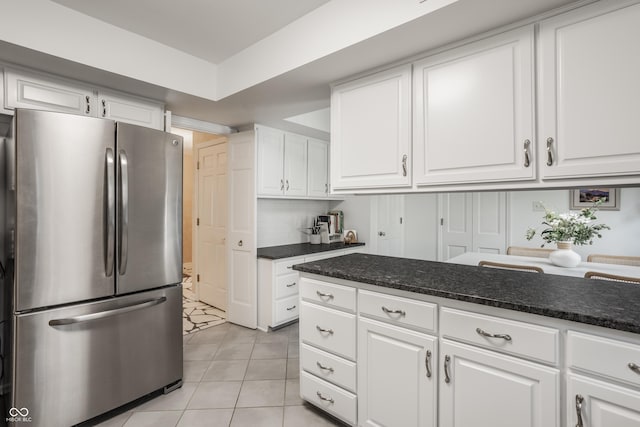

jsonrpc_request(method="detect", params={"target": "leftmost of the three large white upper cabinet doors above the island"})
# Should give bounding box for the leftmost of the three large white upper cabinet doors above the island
[330,65,411,190]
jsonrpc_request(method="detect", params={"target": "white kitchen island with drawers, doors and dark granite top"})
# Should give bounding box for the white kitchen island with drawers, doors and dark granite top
[294,254,640,427]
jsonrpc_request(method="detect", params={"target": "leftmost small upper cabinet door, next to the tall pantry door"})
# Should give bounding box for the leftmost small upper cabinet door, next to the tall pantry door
[256,126,284,196]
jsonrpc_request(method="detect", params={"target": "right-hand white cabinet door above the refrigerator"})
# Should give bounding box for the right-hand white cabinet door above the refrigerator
[98,91,164,130]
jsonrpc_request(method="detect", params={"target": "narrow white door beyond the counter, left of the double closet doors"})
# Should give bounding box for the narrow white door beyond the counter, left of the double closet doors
[371,195,404,256]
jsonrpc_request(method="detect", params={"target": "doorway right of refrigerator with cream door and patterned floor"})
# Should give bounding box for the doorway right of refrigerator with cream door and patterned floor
[171,127,227,334]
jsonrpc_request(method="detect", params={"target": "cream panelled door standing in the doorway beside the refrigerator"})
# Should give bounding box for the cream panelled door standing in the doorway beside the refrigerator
[196,143,228,311]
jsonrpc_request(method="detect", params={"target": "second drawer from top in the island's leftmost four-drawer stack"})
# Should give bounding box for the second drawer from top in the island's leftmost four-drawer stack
[300,301,356,360]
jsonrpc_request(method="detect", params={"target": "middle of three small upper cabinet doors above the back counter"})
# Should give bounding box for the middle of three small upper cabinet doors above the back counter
[284,133,307,196]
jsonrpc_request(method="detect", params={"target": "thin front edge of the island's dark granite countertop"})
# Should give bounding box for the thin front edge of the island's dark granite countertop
[293,264,640,334]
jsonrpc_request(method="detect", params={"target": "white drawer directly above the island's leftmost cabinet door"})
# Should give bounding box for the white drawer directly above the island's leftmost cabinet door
[358,290,438,332]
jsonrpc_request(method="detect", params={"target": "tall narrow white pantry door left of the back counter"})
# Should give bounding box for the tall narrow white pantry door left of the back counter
[227,132,258,329]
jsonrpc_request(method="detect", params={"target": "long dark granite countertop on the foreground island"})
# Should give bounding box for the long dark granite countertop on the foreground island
[293,254,640,333]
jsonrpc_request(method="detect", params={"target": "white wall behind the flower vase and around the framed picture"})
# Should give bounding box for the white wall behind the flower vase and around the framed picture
[509,188,640,261]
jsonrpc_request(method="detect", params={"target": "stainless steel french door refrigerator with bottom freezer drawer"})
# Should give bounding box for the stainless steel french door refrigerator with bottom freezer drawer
[11,110,182,426]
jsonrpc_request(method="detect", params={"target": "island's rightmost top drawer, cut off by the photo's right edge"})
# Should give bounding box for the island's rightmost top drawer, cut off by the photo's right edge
[567,331,640,385]
